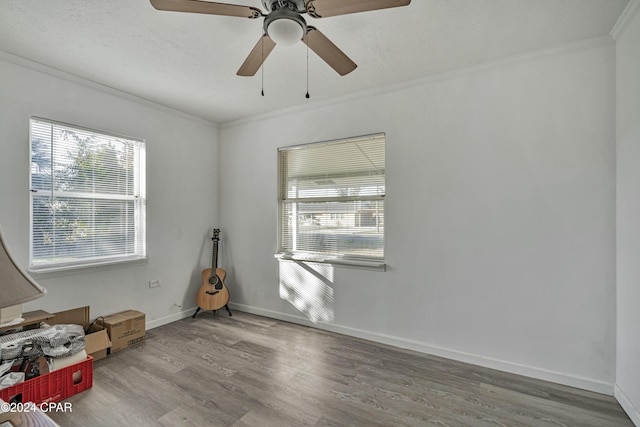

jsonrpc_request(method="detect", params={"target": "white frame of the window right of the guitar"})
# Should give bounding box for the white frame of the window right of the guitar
[274,132,387,271]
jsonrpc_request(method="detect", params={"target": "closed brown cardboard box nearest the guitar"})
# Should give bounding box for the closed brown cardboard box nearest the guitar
[98,310,147,353]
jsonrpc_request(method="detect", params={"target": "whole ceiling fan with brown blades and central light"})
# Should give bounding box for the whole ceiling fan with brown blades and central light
[150,0,411,76]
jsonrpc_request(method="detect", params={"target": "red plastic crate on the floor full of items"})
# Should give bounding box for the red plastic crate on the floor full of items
[0,356,93,404]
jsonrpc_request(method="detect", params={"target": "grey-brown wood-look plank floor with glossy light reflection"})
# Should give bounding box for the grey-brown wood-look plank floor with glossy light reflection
[49,311,633,427]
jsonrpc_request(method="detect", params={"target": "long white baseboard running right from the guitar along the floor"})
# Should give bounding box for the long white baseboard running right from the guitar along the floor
[229,303,614,396]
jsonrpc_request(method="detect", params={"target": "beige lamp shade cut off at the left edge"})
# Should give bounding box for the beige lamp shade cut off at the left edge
[0,230,47,308]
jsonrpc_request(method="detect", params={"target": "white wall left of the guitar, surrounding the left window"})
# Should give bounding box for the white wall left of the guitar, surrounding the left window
[0,54,219,326]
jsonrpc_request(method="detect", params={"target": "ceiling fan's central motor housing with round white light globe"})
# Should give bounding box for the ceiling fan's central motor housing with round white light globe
[262,0,307,46]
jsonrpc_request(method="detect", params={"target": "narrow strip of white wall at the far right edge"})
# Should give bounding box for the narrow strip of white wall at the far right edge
[615,2,640,425]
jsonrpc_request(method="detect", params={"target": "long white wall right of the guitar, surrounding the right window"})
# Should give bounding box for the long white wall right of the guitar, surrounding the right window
[220,39,616,394]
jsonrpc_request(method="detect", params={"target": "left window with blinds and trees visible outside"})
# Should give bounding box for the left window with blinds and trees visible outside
[30,117,146,271]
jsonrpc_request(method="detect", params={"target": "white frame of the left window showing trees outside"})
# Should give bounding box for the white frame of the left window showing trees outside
[28,116,147,274]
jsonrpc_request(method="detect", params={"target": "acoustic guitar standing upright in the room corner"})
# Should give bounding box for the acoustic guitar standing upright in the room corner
[192,228,231,318]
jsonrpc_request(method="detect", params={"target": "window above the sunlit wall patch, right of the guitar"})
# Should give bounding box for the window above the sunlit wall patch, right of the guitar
[278,134,385,267]
